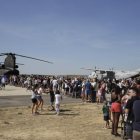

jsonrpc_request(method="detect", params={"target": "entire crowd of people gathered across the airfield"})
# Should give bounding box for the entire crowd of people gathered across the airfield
[1,75,140,140]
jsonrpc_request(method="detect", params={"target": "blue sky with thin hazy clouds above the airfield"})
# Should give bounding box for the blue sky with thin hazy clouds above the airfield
[0,0,140,75]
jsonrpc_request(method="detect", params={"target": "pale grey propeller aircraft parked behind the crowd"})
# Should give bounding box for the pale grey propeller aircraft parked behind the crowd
[81,67,140,80]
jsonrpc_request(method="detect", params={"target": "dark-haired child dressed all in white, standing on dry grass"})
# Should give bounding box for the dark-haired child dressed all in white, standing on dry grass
[55,90,62,115]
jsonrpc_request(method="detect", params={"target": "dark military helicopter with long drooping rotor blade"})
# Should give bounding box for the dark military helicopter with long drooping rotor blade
[0,53,53,75]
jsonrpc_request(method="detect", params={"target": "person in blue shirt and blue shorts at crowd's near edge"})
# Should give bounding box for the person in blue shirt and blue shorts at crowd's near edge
[85,79,91,103]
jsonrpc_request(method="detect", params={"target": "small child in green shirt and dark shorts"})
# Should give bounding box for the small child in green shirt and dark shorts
[102,101,109,129]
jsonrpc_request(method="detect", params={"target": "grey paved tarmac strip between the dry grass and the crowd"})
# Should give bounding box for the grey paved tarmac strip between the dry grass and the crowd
[0,85,81,108]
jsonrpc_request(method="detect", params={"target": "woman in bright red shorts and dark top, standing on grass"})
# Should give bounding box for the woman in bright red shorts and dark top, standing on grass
[111,84,121,137]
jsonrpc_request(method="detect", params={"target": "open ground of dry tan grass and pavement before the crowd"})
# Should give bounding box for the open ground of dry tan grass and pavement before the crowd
[0,86,121,140]
